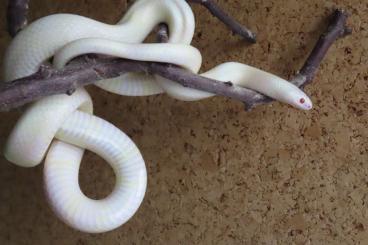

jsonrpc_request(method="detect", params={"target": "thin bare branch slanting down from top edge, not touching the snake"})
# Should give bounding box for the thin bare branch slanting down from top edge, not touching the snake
[187,0,256,43]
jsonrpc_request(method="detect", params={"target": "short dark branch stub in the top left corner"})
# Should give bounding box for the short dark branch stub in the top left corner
[7,0,29,37]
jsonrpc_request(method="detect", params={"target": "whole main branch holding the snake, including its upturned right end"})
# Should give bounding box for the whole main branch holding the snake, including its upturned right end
[0,1,350,111]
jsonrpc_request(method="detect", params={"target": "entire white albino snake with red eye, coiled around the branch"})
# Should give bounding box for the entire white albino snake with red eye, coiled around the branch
[4,0,312,233]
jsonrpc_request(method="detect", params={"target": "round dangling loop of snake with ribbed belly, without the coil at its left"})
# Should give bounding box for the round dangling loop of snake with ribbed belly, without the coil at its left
[44,111,147,233]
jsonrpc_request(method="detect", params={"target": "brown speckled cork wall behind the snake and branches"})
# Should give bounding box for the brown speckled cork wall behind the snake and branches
[0,0,368,245]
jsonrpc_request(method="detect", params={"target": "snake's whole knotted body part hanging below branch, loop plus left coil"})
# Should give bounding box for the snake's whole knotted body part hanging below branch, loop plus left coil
[4,89,147,233]
